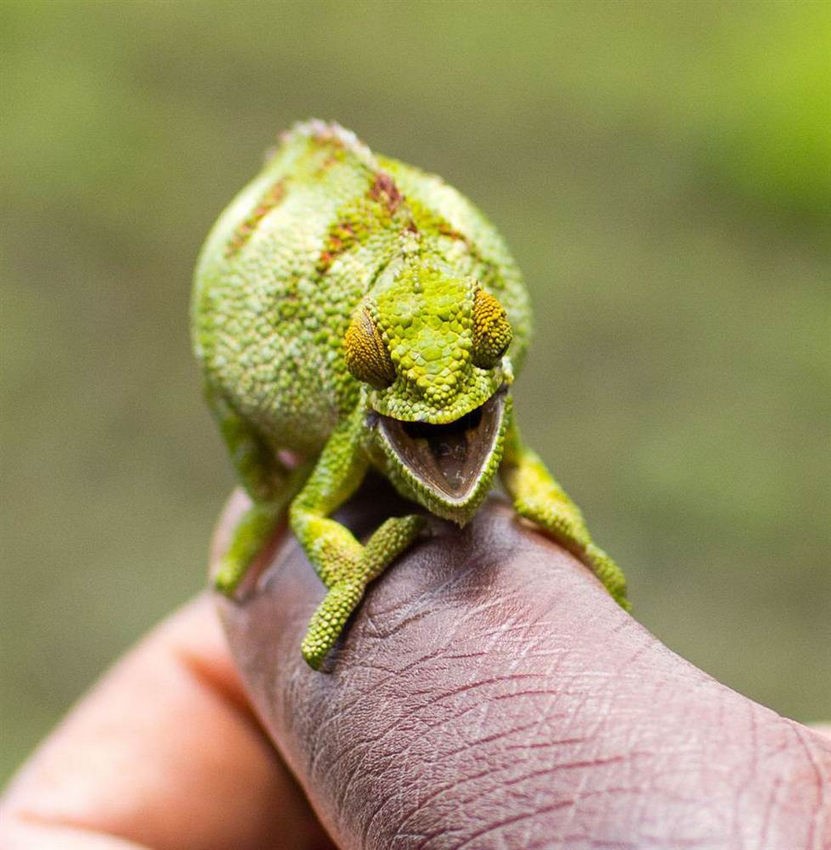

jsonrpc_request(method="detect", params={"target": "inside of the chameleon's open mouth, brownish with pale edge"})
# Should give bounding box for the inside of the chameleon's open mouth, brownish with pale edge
[378,391,505,505]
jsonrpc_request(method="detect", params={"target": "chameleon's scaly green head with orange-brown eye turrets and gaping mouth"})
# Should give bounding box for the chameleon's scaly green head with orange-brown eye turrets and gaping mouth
[344,259,513,524]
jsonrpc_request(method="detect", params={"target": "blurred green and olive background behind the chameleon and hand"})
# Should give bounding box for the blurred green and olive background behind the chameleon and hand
[0,0,831,778]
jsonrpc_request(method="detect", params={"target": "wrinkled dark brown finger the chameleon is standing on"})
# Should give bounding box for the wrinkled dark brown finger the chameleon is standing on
[216,484,831,850]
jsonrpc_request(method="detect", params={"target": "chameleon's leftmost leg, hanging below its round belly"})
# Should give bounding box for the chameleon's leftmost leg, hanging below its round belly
[206,387,306,596]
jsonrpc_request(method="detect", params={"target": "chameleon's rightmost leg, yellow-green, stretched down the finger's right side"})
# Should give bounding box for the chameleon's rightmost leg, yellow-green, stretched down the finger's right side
[500,414,629,610]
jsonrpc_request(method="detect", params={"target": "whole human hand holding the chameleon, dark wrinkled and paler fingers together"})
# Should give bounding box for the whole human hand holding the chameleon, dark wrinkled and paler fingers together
[0,476,831,850]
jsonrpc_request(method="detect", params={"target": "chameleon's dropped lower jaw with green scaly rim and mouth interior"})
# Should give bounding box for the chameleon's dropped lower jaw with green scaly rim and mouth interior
[376,386,507,510]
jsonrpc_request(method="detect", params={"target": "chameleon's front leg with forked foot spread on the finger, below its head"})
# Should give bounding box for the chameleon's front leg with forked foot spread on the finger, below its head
[289,410,424,670]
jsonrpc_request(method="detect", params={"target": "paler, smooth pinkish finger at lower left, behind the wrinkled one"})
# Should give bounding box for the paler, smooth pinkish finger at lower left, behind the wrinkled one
[0,595,332,850]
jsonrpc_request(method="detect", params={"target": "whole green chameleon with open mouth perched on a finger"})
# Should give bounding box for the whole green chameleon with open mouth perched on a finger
[193,121,627,669]
